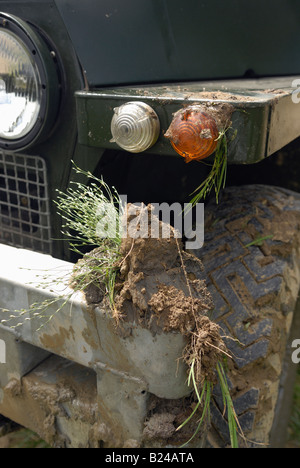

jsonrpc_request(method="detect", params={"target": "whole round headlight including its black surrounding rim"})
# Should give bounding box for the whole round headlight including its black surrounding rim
[0,13,60,150]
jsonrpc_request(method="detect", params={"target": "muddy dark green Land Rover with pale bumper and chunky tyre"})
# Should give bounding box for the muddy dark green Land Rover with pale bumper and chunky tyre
[0,0,300,448]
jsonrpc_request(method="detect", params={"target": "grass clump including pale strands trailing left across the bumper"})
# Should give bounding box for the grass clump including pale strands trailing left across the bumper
[1,165,122,330]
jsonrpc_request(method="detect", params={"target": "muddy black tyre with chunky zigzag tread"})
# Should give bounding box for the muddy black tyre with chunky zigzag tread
[195,185,300,447]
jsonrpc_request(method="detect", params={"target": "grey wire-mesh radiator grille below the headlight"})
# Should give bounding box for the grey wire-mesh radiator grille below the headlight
[0,153,52,254]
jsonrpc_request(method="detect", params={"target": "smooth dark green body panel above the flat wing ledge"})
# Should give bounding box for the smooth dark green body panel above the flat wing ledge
[55,0,300,86]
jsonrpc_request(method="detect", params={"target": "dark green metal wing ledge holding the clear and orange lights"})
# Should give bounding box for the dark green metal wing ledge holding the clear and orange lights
[75,76,300,164]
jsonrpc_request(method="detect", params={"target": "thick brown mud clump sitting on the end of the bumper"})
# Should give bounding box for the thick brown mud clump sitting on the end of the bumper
[115,205,213,334]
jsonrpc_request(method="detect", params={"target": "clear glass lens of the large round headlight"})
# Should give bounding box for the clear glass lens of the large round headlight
[0,31,41,140]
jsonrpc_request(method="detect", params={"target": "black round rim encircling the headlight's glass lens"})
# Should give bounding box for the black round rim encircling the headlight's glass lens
[0,12,62,151]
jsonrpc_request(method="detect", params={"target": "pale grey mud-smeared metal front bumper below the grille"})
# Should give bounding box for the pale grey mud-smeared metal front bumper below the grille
[0,244,190,447]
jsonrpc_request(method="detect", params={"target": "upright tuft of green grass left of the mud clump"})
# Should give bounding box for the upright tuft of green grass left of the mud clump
[56,166,123,308]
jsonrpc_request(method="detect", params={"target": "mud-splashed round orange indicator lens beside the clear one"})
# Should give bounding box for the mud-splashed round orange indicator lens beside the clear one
[165,106,219,162]
